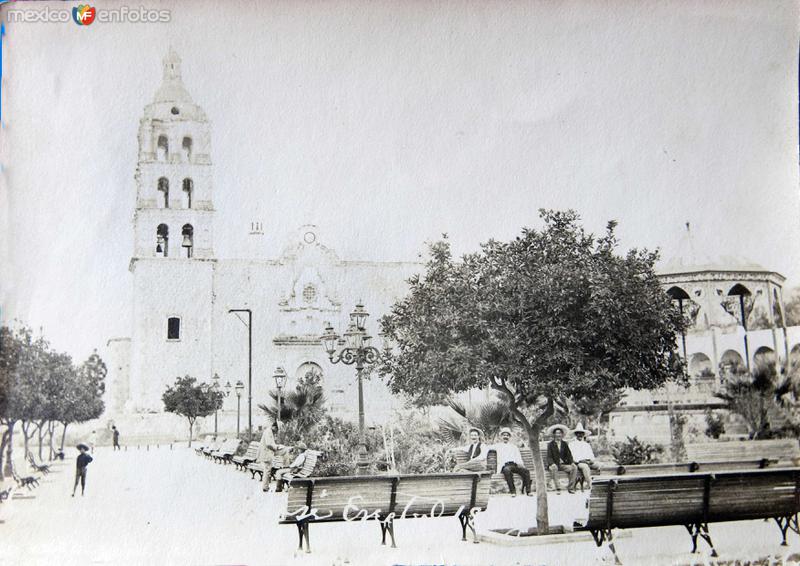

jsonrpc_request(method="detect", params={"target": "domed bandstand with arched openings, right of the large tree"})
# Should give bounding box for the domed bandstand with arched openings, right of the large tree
[610,225,800,443]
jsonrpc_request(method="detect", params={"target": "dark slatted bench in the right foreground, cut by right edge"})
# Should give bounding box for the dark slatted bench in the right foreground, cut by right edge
[582,468,800,563]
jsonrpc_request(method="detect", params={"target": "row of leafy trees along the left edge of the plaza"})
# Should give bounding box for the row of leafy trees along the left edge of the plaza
[0,326,107,477]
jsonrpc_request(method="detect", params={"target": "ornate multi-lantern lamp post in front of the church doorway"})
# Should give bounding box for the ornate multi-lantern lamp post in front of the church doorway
[320,303,380,470]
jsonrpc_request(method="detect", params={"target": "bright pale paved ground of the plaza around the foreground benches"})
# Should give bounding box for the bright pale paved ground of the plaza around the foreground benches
[0,447,800,566]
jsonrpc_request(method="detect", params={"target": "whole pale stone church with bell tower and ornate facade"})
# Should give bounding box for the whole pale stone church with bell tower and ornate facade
[106,50,421,430]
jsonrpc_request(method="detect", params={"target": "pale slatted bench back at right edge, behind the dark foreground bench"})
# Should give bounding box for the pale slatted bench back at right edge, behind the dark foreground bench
[686,438,800,465]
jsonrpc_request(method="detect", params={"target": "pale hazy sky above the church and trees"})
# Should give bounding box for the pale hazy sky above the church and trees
[0,0,800,358]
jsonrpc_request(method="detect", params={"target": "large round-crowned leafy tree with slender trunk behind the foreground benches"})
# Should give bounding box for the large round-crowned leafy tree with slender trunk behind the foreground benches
[379,211,686,533]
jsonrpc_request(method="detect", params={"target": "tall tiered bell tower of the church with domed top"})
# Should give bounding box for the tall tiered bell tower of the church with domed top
[126,49,215,412]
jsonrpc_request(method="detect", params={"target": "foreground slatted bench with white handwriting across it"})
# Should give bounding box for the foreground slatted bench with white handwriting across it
[280,472,489,552]
